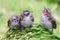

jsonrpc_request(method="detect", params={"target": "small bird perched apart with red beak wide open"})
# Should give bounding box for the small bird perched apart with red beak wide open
[40,8,57,31]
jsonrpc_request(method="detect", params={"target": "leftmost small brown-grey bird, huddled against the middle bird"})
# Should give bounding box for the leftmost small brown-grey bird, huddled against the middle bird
[8,15,21,29]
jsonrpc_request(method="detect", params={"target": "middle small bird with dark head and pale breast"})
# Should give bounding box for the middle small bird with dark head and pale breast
[20,10,34,27]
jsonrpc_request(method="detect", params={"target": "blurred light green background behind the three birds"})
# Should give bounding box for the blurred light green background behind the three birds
[0,0,60,38]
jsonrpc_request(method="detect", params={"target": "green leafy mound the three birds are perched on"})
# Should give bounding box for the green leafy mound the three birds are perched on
[1,24,60,40]
